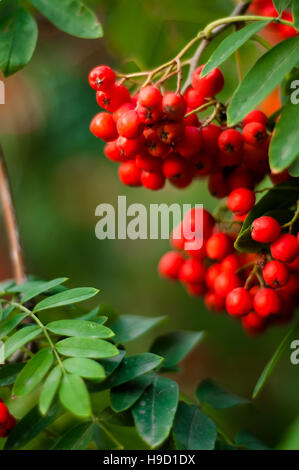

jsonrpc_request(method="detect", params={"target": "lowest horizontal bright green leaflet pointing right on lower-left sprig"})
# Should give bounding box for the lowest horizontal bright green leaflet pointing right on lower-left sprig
[56,337,118,359]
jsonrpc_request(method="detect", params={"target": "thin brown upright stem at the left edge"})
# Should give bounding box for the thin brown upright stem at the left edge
[0,146,26,284]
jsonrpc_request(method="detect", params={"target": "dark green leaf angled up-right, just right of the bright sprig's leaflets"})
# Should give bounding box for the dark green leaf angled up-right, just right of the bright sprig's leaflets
[111,353,163,387]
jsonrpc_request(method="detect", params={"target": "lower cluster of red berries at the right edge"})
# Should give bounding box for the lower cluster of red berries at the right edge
[158,202,299,334]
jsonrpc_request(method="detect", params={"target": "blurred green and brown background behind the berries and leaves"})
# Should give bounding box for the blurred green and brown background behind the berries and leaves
[0,0,299,448]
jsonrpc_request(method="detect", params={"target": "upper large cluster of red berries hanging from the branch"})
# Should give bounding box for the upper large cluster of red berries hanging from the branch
[89,65,288,193]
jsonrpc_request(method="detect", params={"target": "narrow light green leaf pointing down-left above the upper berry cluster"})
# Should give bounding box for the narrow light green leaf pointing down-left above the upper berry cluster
[201,20,270,77]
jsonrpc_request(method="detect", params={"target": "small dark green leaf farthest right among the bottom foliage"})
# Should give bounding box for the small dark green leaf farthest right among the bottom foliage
[196,379,249,410]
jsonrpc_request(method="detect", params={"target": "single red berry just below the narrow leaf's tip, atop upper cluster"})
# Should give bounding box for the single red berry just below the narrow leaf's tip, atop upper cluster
[192,65,224,98]
